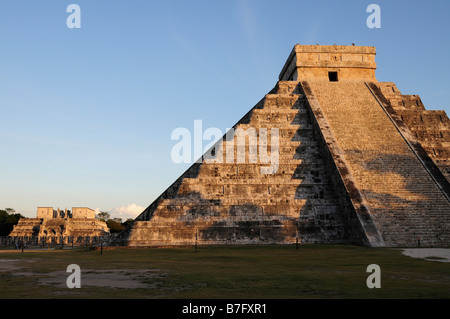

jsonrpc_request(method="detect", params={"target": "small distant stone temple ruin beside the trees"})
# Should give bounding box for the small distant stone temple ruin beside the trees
[9,207,109,244]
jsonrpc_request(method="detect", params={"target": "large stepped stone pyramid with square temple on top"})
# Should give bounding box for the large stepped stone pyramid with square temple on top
[112,44,450,247]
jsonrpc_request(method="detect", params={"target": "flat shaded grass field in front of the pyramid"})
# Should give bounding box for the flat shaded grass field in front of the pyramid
[0,245,450,299]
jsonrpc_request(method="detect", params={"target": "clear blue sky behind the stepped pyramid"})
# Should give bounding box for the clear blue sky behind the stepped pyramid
[0,0,450,218]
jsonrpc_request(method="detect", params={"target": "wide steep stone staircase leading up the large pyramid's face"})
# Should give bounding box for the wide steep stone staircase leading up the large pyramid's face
[305,80,450,246]
